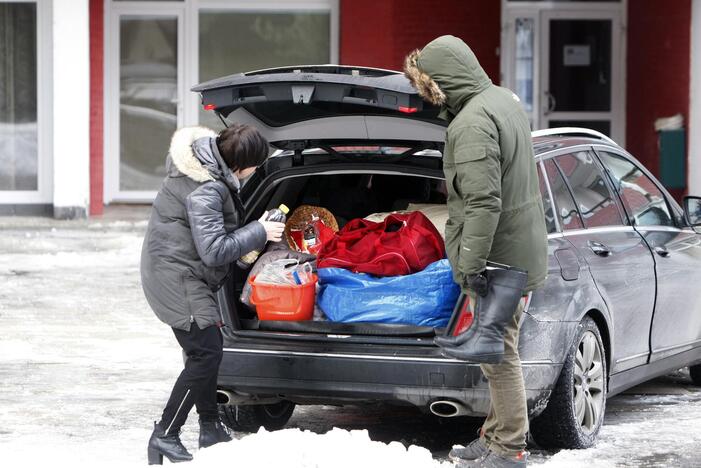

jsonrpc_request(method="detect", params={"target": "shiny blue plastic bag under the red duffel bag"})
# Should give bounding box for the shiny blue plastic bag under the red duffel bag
[317,259,460,327]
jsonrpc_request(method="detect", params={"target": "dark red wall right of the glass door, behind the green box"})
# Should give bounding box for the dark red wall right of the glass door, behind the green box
[626,0,691,197]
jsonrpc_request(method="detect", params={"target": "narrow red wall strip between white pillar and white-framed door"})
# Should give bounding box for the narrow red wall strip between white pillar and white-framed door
[90,0,104,215]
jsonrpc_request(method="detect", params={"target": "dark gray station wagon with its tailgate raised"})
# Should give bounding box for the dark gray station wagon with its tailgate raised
[193,65,701,448]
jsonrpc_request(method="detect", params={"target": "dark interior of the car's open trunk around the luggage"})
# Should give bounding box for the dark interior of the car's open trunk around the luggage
[228,164,447,340]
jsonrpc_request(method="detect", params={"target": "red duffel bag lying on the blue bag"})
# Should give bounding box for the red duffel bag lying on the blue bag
[317,211,445,276]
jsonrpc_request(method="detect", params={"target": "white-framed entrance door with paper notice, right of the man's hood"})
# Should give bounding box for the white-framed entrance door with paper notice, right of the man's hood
[501,5,625,144]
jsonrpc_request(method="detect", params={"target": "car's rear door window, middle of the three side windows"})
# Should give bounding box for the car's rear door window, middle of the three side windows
[555,151,623,228]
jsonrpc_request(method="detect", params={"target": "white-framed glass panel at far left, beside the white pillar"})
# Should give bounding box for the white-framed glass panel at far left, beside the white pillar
[0,1,52,204]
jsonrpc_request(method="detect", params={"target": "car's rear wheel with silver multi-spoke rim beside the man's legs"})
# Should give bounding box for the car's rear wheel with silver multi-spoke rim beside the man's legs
[530,317,607,449]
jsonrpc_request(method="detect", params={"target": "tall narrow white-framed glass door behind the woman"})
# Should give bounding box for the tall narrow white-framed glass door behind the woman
[105,5,183,202]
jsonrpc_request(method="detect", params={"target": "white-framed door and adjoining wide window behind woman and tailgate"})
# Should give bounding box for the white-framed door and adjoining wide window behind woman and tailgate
[105,0,338,199]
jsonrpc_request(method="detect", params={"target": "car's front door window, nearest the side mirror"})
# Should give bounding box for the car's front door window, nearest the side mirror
[599,152,674,226]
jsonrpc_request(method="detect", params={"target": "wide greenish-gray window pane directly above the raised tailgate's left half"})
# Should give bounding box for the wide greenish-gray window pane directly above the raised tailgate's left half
[199,10,331,128]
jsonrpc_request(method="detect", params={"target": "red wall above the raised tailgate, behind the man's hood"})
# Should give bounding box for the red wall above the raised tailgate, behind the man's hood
[340,0,501,84]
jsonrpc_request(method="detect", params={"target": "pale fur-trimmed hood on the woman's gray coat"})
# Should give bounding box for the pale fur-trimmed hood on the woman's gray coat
[168,127,240,191]
